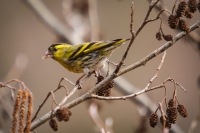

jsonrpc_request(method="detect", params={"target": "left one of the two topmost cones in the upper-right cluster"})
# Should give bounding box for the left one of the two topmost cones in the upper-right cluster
[176,1,187,17]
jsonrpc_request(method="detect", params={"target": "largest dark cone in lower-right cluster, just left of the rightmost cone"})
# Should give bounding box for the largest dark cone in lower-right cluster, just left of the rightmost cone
[166,107,177,124]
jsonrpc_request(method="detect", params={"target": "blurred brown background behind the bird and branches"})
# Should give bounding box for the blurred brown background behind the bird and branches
[0,0,200,133]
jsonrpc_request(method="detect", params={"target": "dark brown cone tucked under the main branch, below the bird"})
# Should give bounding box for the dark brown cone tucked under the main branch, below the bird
[96,80,114,97]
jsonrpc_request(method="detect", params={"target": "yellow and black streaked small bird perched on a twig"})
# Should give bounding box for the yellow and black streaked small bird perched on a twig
[42,39,130,87]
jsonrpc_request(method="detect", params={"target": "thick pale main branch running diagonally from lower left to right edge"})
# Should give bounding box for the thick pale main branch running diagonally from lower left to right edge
[31,20,200,130]
